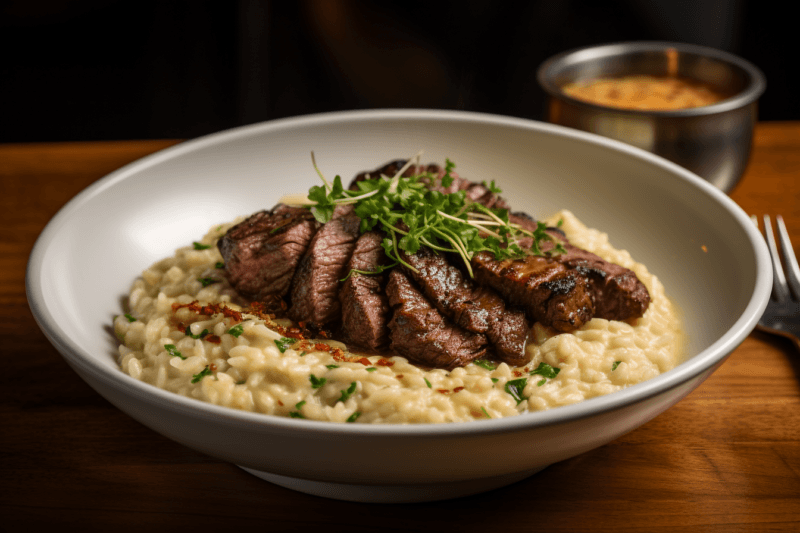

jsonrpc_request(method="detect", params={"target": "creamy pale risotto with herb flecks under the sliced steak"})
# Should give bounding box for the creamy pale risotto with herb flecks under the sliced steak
[114,211,681,424]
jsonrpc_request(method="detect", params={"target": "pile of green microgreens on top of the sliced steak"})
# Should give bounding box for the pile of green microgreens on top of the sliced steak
[292,152,564,277]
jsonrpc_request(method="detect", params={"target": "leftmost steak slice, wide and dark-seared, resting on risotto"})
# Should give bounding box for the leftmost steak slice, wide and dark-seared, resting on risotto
[217,204,319,303]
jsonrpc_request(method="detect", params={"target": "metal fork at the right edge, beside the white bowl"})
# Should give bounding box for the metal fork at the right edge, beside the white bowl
[750,215,800,350]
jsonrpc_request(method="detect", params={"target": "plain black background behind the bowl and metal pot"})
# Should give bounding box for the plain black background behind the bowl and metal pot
[0,0,800,142]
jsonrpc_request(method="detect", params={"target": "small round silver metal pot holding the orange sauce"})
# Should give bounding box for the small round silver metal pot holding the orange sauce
[537,42,766,192]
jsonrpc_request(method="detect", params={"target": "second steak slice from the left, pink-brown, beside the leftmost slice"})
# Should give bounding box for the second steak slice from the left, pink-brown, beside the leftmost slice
[289,214,361,326]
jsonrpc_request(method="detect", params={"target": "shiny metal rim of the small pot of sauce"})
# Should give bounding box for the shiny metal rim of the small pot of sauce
[536,41,767,117]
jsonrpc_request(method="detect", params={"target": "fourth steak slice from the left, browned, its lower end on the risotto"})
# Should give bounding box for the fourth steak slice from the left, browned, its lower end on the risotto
[386,268,486,370]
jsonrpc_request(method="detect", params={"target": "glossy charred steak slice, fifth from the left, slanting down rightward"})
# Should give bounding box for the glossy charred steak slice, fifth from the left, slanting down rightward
[402,247,530,366]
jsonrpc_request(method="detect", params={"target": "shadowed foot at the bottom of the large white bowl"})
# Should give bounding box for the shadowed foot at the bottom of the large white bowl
[239,465,547,503]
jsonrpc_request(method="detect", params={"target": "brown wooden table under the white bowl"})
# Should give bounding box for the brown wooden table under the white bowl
[0,123,800,532]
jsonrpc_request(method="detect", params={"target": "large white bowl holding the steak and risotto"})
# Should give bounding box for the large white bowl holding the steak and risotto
[27,110,771,502]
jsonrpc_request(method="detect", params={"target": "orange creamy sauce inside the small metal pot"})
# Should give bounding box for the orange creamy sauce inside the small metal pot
[561,76,729,111]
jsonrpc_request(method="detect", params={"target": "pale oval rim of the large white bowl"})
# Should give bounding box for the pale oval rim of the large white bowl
[25,109,772,438]
